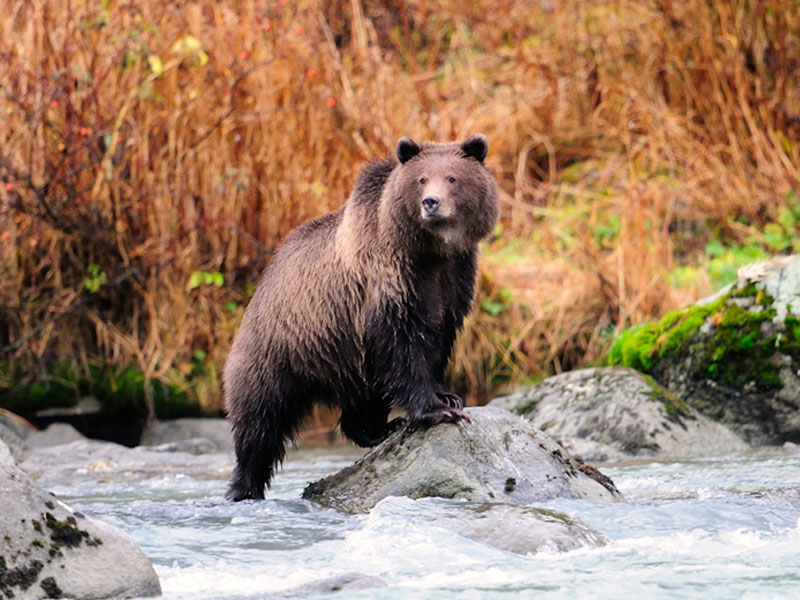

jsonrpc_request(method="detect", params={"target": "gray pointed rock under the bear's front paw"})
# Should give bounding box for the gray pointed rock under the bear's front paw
[303,407,622,512]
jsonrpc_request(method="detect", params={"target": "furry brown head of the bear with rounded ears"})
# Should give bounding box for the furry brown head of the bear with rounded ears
[381,134,498,253]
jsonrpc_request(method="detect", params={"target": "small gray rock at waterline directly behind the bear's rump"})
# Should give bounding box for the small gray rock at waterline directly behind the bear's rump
[140,418,233,454]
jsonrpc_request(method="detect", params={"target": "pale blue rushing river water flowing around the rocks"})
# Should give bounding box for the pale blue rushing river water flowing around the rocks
[53,448,800,600]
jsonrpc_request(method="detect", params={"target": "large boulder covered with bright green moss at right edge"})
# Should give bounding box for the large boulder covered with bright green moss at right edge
[609,255,800,445]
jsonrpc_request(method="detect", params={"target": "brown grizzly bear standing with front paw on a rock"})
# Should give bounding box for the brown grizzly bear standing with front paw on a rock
[223,135,498,501]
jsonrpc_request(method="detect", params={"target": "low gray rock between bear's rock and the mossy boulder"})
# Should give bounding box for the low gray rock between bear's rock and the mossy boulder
[490,367,749,461]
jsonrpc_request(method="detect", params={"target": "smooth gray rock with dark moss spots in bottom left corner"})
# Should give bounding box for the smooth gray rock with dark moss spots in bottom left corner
[0,464,161,600]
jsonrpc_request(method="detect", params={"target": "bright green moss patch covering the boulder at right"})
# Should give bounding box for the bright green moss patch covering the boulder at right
[608,283,788,390]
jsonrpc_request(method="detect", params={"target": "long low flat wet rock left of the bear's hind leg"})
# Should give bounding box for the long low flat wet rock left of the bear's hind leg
[20,440,233,489]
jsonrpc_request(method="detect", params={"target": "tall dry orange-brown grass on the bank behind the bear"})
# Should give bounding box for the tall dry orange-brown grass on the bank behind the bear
[0,0,800,408]
